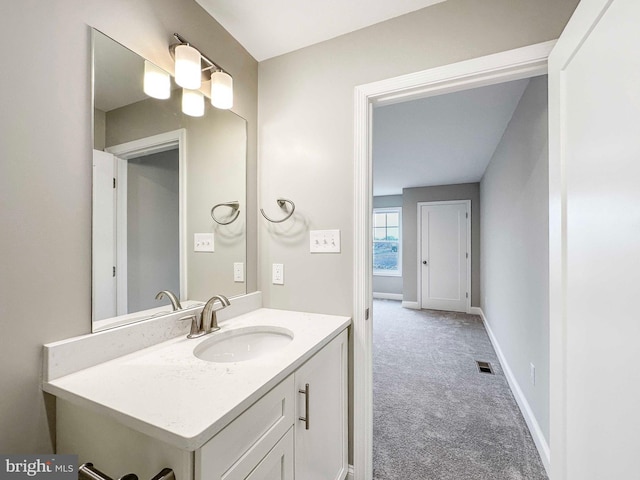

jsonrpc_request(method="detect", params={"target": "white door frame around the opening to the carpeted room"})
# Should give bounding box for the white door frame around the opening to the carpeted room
[352,40,555,480]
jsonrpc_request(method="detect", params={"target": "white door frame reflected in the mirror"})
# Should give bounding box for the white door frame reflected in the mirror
[105,128,188,308]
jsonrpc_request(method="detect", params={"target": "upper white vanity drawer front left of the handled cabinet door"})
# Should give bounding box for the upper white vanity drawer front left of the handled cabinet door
[196,375,294,480]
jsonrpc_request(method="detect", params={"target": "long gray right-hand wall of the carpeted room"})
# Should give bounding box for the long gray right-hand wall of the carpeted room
[480,76,549,442]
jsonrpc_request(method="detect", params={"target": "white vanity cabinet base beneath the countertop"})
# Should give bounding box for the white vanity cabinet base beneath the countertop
[57,329,348,480]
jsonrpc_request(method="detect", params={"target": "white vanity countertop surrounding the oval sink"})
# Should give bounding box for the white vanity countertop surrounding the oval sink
[43,308,351,450]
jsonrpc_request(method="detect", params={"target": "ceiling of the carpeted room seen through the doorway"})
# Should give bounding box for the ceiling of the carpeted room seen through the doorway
[373,79,529,196]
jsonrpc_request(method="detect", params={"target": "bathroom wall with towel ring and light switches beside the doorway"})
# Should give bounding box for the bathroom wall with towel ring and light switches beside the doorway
[258,0,578,464]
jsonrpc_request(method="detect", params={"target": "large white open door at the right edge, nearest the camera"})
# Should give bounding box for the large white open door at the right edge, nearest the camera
[549,0,640,480]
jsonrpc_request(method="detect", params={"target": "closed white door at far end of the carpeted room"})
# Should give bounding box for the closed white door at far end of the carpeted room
[418,202,469,312]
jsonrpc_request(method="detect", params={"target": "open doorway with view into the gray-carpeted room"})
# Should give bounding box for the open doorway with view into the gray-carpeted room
[372,76,549,480]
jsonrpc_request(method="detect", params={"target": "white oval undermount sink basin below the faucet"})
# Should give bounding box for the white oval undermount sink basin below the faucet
[193,326,293,363]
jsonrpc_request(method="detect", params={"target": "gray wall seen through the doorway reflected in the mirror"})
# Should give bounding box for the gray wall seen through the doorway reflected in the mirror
[127,149,180,312]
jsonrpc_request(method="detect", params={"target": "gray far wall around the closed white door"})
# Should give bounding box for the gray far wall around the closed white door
[402,183,481,306]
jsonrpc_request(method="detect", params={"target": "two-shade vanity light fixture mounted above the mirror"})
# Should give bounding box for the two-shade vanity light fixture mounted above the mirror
[169,33,233,115]
